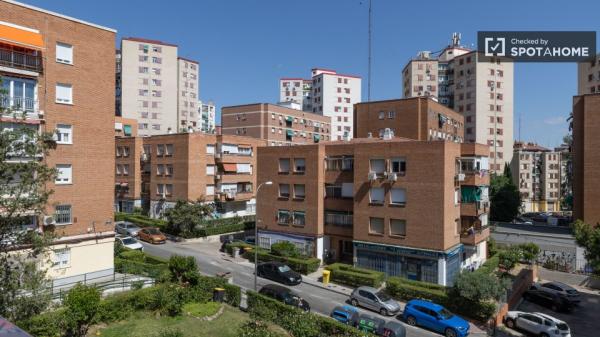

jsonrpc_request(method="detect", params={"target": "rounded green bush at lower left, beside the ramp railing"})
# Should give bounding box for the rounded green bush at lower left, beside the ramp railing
[63,283,100,337]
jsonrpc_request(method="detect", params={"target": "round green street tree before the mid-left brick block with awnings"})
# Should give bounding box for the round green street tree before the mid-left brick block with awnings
[165,200,213,237]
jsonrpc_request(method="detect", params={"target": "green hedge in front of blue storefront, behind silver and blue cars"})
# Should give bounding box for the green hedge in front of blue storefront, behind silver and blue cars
[386,277,496,322]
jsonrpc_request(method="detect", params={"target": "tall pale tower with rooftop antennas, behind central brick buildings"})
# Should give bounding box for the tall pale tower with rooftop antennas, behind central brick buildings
[402,34,514,172]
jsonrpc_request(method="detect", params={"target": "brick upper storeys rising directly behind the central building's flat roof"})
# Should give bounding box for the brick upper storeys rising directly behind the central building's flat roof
[354,97,465,143]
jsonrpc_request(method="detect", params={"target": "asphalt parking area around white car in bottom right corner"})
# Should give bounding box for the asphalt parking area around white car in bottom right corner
[517,292,600,337]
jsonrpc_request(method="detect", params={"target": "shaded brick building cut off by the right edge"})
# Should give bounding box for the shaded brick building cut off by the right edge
[573,94,600,225]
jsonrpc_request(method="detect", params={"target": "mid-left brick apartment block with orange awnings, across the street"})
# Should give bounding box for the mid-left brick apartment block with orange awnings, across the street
[115,133,265,217]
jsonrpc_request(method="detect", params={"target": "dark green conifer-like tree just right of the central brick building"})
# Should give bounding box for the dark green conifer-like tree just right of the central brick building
[490,165,521,222]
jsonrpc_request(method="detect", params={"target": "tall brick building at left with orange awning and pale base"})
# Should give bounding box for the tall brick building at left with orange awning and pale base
[0,0,116,284]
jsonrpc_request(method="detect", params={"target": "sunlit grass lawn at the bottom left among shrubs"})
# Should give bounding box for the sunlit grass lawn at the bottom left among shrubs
[88,305,249,337]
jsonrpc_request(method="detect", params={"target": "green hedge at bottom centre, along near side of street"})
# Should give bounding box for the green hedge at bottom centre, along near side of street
[246,291,374,337]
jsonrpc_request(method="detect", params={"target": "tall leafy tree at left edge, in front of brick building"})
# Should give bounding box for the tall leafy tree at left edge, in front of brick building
[0,79,56,321]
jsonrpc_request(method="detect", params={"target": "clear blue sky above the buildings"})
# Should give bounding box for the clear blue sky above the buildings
[21,0,600,147]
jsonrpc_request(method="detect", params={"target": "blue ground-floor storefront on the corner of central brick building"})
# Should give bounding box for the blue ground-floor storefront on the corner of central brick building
[354,241,463,285]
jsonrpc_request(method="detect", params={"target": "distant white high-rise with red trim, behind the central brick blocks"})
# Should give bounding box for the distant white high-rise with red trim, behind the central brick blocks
[279,68,361,140]
